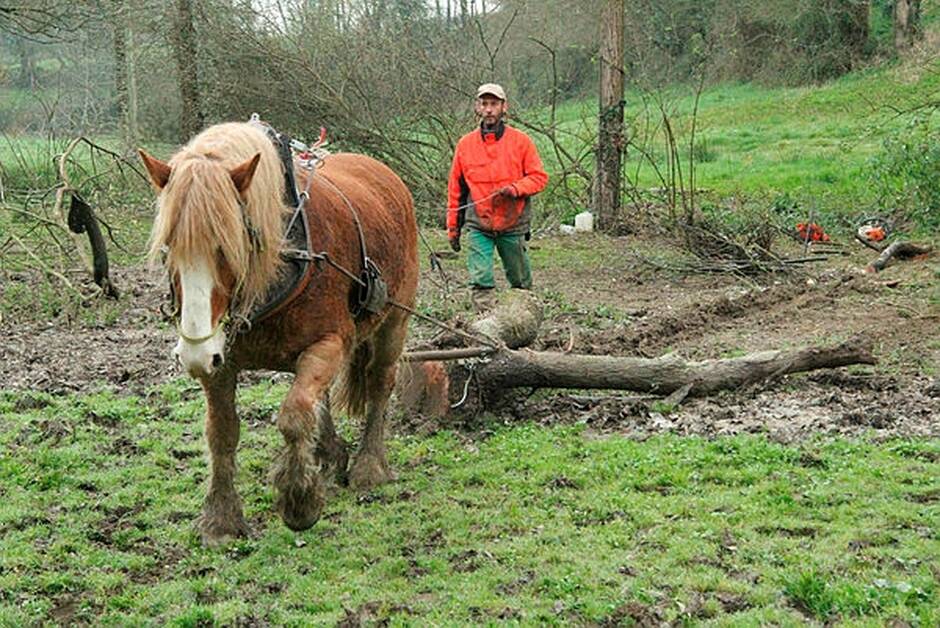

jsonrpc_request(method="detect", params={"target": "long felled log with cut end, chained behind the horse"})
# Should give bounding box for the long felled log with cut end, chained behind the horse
[399,290,876,417]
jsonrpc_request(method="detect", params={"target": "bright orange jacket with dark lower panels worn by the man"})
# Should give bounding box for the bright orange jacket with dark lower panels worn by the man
[447,124,548,238]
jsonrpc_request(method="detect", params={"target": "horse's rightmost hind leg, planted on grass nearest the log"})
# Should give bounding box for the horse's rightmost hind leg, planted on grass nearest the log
[349,309,408,491]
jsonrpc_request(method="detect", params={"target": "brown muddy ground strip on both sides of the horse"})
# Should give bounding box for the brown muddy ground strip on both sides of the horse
[0,236,940,441]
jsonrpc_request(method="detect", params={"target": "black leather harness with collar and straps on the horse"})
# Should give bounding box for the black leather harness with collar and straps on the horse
[170,114,389,336]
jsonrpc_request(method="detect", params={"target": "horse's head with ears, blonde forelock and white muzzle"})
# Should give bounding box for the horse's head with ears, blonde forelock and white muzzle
[140,151,261,378]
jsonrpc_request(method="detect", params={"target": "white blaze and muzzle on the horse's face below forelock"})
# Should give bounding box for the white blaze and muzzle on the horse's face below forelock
[173,260,225,375]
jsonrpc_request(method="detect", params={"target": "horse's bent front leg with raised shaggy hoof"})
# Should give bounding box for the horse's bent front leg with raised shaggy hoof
[273,335,344,530]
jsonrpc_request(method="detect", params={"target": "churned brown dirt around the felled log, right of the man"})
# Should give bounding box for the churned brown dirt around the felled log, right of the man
[511,243,940,440]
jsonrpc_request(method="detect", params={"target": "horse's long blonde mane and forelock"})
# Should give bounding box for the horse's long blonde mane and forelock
[150,122,289,314]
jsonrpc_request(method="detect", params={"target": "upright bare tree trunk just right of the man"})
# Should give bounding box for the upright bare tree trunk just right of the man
[593,0,624,230]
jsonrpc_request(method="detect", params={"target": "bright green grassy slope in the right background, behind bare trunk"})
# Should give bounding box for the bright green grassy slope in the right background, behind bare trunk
[523,59,940,226]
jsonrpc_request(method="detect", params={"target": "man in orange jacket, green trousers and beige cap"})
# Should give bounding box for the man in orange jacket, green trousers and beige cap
[447,83,548,290]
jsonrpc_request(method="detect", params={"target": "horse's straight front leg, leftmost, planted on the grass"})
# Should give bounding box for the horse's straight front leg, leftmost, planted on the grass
[198,369,248,546]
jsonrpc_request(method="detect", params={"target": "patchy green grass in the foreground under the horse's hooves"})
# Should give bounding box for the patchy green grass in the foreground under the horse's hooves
[0,381,940,626]
